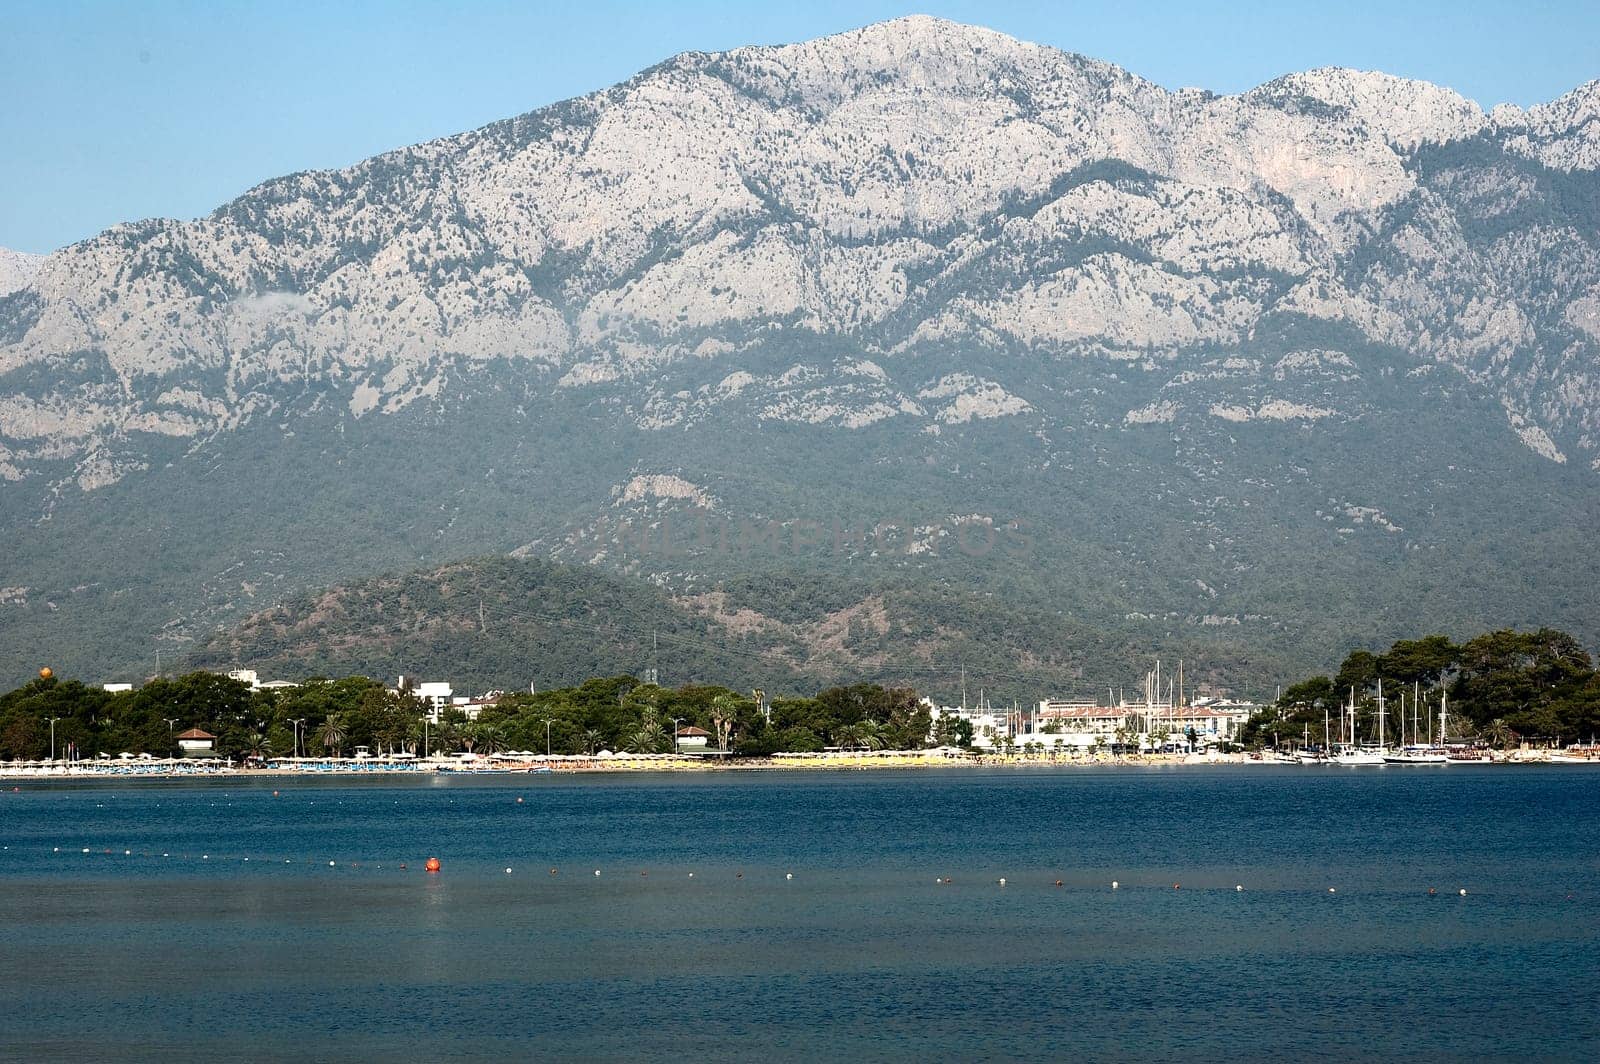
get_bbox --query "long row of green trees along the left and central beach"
[0,672,934,760]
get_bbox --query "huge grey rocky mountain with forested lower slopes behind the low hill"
[0,16,1600,688]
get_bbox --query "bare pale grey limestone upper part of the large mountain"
[0,16,1600,490]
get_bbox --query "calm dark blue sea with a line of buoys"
[0,765,1600,1062]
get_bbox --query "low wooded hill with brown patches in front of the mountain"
[187,557,1228,701]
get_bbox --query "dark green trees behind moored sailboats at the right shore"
[1246,629,1600,746]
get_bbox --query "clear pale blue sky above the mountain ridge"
[0,0,1600,251]
